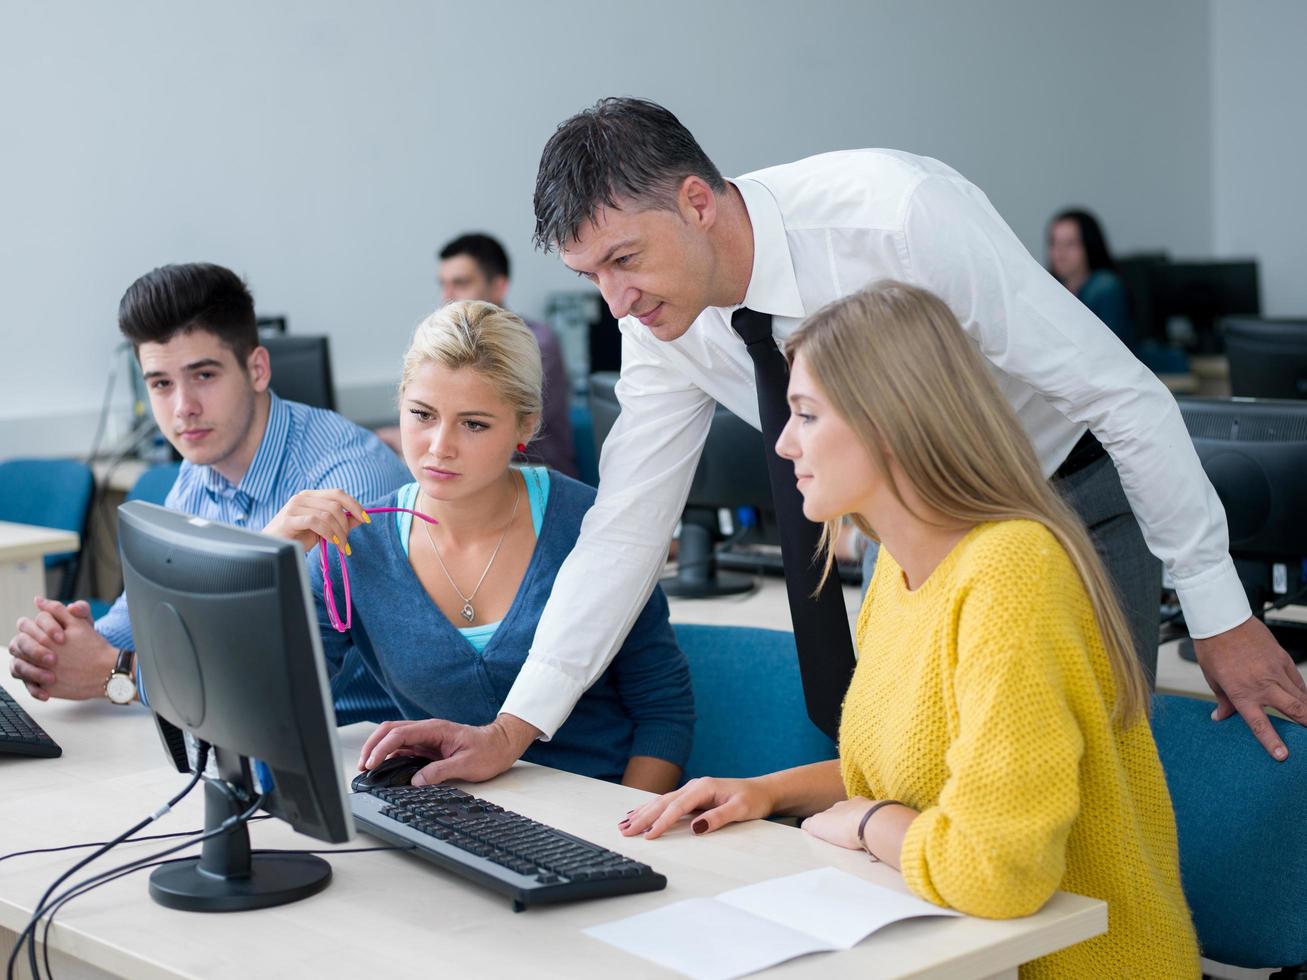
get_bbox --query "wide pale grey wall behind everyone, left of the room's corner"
[0,0,1213,457]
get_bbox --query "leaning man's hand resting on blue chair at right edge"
[1193,617,1307,762]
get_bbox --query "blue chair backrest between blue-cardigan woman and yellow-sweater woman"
[674,623,836,779]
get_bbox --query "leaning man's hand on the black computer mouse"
[358,715,540,785]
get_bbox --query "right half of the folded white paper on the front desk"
[715,868,959,950]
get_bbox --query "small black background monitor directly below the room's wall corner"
[1150,260,1261,354]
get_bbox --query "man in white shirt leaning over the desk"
[365,98,1307,779]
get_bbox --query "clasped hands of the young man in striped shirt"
[9,596,118,700]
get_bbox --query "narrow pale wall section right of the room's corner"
[1212,0,1307,316]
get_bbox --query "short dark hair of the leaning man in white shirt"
[535,98,725,252]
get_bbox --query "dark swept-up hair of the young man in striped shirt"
[118,263,259,368]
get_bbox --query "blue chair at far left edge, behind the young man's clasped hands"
[0,459,95,601]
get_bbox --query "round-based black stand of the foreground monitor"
[150,749,331,912]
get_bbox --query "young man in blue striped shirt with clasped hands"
[9,263,409,724]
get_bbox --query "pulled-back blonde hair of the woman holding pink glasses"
[400,299,544,438]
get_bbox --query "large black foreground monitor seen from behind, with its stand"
[118,500,354,912]
